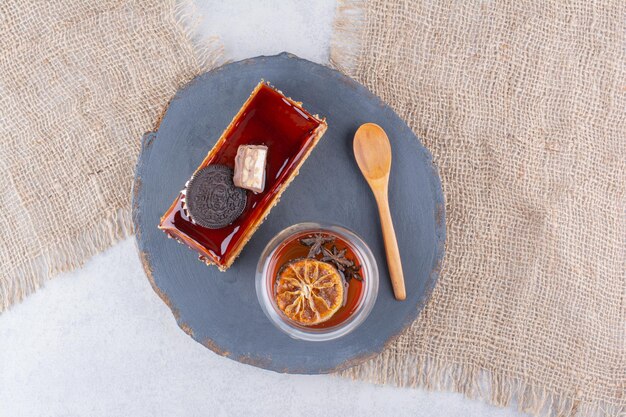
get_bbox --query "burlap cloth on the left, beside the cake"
[0,0,218,311]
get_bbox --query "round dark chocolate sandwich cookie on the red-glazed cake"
[185,165,246,229]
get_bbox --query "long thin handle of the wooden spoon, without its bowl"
[376,190,406,301]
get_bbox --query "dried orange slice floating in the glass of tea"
[276,258,344,326]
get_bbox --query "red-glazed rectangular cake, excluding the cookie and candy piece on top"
[160,84,323,266]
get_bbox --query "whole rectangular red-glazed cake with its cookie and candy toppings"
[159,82,327,271]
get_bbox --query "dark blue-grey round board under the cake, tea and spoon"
[133,53,445,374]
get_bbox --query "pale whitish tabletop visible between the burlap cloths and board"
[0,0,521,417]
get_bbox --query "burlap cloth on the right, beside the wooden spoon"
[331,0,626,416]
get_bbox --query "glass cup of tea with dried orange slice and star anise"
[256,223,378,341]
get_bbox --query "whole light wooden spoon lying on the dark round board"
[353,123,406,300]
